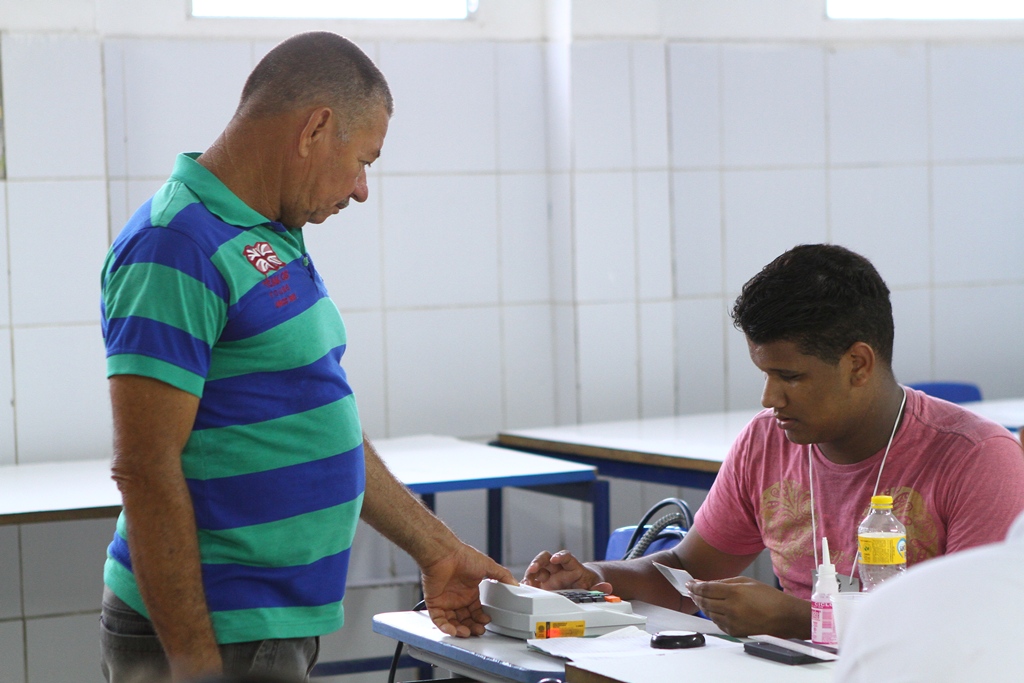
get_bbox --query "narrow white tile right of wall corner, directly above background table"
[577,303,640,422]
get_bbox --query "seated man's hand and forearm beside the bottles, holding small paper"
[686,577,811,639]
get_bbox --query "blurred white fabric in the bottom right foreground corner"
[835,514,1024,683]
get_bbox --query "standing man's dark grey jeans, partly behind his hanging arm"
[99,588,319,683]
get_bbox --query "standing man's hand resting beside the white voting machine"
[420,544,518,638]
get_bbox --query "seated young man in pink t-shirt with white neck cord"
[524,245,1024,638]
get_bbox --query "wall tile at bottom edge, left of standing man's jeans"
[26,609,103,683]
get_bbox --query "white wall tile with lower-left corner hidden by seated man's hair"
[828,166,931,289]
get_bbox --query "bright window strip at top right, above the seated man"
[825,0,1024,20]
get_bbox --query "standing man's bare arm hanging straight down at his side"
[110,375,221,681]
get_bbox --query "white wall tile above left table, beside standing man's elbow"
[14,325,113,464]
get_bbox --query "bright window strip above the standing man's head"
[191,0,478,19]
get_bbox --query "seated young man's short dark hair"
[732,245,893,368]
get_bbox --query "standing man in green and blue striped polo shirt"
[101,33,515,683]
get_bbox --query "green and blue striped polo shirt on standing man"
[102,155,365,643]
